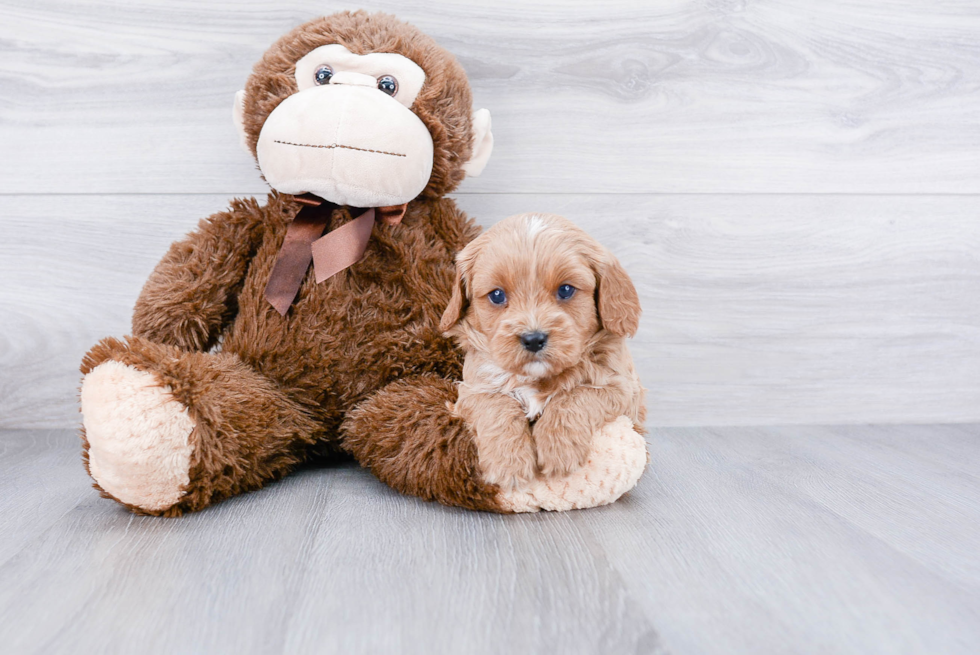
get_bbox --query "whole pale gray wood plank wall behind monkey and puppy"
[0,0,980,428]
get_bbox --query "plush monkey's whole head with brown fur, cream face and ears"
[234,11,493,207]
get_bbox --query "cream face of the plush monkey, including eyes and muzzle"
[256,44,432,207]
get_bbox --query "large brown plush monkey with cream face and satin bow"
[81,7,645,516]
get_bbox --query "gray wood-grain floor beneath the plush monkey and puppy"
[0,425,980,655]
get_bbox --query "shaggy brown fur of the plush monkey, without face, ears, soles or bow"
[82,12,500,516]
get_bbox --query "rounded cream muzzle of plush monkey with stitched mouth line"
[256,84,433,207]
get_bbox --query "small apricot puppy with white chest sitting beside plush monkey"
[440,214,646,487]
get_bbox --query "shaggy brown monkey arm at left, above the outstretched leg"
[133,199,265,351]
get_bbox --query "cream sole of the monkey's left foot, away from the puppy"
[81,360,194,513]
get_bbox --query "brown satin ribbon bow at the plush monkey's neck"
[265,193,408,316]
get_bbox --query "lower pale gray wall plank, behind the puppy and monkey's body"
[0,194,980,428]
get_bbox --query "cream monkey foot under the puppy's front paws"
[498,416,648,512]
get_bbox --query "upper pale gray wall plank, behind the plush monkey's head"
[0,0,980,194]
